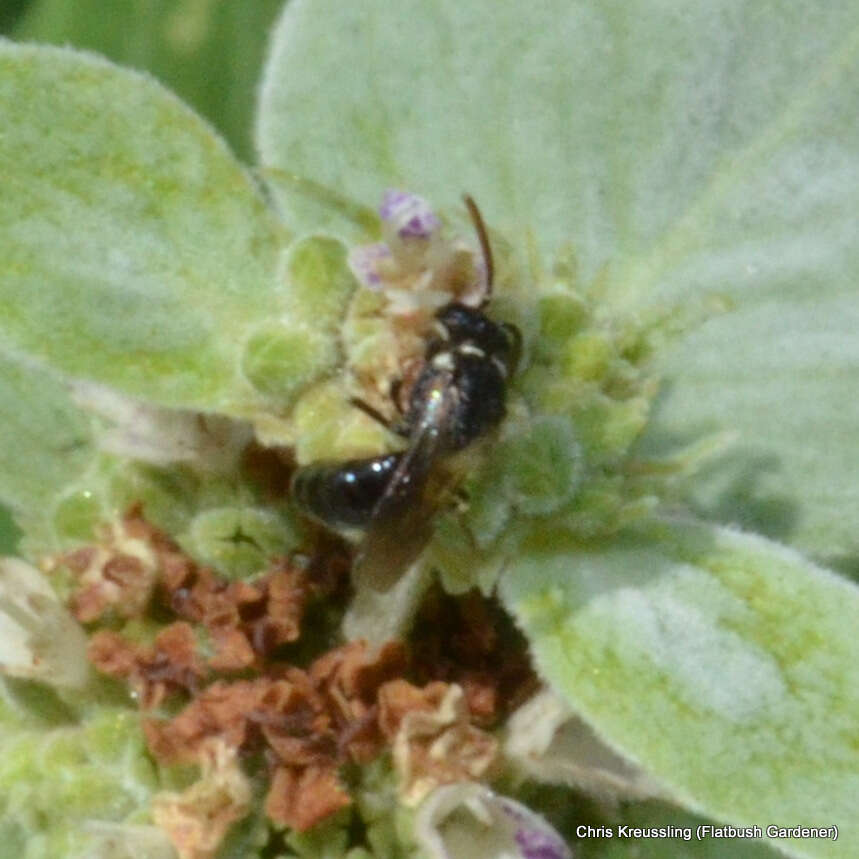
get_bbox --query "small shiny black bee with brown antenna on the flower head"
[292,196,521,590]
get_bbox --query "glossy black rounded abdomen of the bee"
[292,453,402,528]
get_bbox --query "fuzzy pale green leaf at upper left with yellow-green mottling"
[0,43,320,414]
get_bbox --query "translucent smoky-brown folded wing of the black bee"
[354,416,451,591]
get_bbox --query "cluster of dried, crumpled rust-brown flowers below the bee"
[72,507,533,848]
